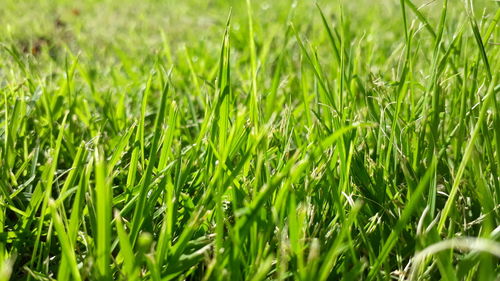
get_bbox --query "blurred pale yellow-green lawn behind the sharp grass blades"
[0,0,498,98]
